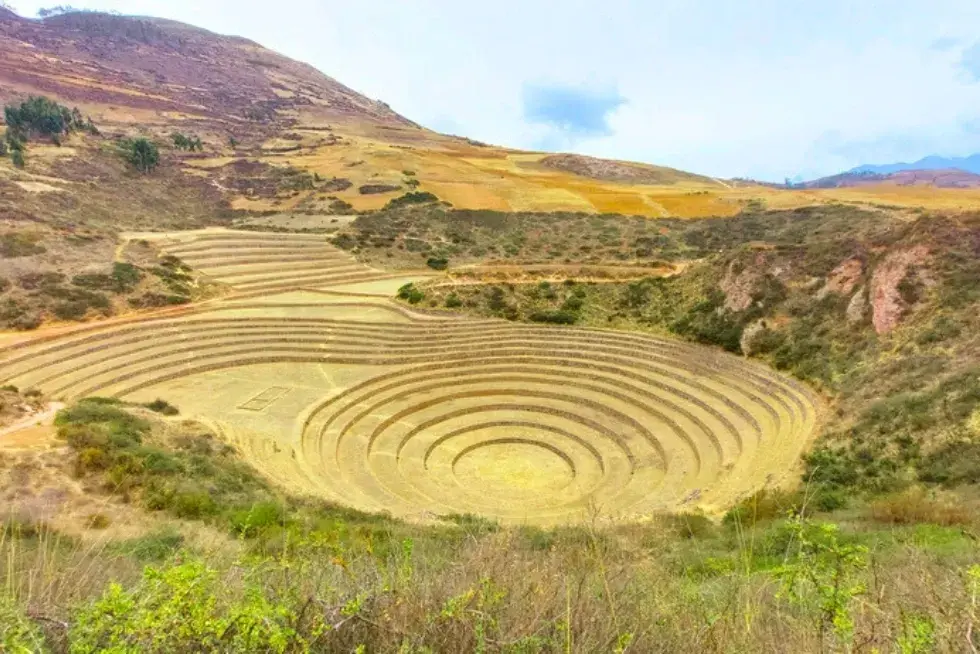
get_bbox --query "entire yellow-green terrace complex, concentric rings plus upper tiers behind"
[0,250,818,524]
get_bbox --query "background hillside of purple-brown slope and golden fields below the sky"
[0,12,980,223]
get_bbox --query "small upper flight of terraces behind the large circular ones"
[127,229,422,295]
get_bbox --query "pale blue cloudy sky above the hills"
[9,0,980,180]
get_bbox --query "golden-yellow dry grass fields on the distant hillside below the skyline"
[224,115,980,218]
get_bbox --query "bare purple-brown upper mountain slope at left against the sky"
[0,12,411,131]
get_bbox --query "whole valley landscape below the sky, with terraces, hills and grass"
[0,3,980,654]
